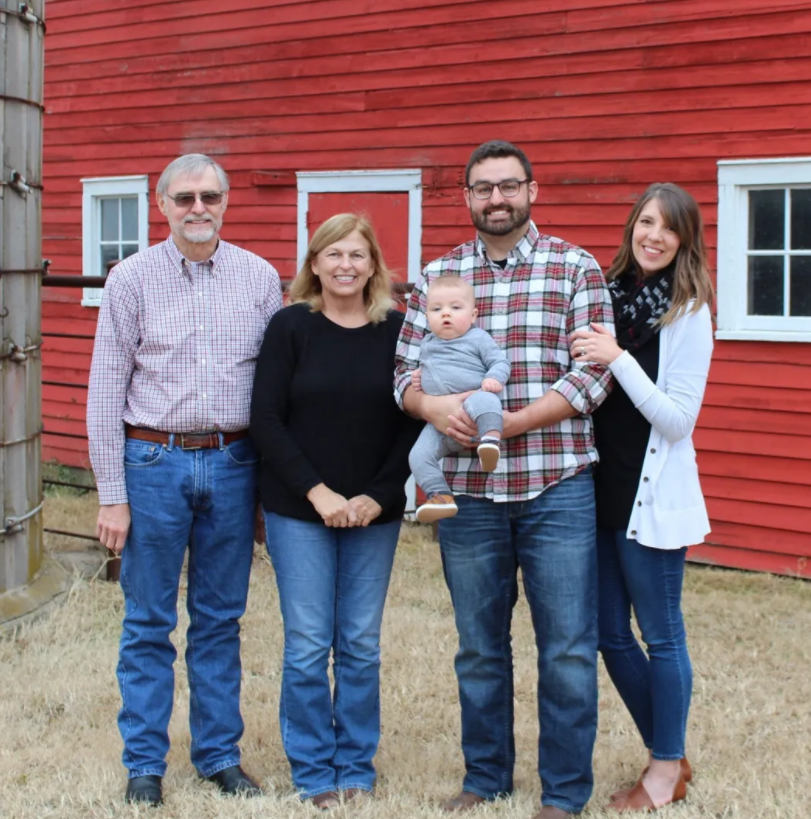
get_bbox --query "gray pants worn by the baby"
[408,390,504,498]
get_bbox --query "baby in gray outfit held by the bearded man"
[408,276,510,523]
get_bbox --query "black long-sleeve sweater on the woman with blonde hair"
[251,304,422,525]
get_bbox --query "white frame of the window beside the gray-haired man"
[81,175,149,307]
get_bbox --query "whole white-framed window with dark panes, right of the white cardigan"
[716,158,811,341]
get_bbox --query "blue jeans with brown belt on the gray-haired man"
[117,438,258,778]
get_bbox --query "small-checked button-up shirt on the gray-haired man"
[87,238,282,505]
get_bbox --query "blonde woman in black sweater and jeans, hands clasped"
[251,213,421,810]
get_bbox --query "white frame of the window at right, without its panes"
[715,157,811,341]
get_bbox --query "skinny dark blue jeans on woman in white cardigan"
[597,527,693,759]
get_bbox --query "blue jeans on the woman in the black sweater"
[265,512,400,798]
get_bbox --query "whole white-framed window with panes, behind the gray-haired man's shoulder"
[82,176,149,306]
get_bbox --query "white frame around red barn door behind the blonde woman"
[296,168,422,282]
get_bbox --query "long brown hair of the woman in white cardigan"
[605,182,713,327]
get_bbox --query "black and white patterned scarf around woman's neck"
[608,265,675,350]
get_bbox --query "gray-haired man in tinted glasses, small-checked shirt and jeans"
[87,154,282,805]
